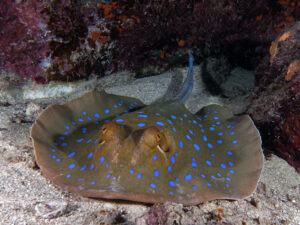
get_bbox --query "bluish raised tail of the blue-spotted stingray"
[173,52,194,102]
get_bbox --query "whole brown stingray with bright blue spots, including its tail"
[31,56,263,205]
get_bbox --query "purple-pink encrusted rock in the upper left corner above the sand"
[0,0,49,82]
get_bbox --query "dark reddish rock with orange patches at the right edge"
[248,22,300,172]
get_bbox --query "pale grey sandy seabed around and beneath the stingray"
[0,67,300,225]
